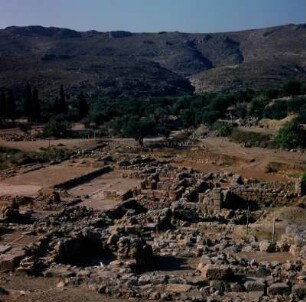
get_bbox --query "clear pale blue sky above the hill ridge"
[0,0,306,32]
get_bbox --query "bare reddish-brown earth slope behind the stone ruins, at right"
[175,137,306,181]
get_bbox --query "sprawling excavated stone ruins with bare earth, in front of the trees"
[0,138,306,302]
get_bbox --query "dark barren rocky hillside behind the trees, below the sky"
[0,24,306,97]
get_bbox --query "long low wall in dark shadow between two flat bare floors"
[53,166,113,190]
